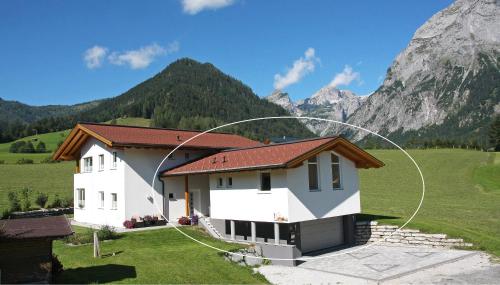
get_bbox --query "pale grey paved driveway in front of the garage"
[259,245,500,284]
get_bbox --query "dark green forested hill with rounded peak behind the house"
[0,58,313,142]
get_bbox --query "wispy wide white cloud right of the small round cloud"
[108,41,179,69]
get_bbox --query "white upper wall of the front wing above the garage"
[210,152,360,223]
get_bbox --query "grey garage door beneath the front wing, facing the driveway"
[300,217,344,253]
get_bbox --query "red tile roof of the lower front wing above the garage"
[163,137,336,176]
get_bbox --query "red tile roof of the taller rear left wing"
[80,123,261,149]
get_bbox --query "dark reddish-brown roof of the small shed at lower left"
[0,216,73,239]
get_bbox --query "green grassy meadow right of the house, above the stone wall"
[361,149,500,256]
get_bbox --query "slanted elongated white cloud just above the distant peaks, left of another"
[274,48,319,89]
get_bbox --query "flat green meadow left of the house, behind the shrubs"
[0,162,75,212]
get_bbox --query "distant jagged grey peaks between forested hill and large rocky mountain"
[266,86,367,135]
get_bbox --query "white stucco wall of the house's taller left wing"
[74,138,208,227]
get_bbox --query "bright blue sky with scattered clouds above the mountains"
[0,0,452,105]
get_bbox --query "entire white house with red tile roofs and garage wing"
[54,124,383,262]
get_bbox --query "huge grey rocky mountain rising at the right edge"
[327,0,500,144]
